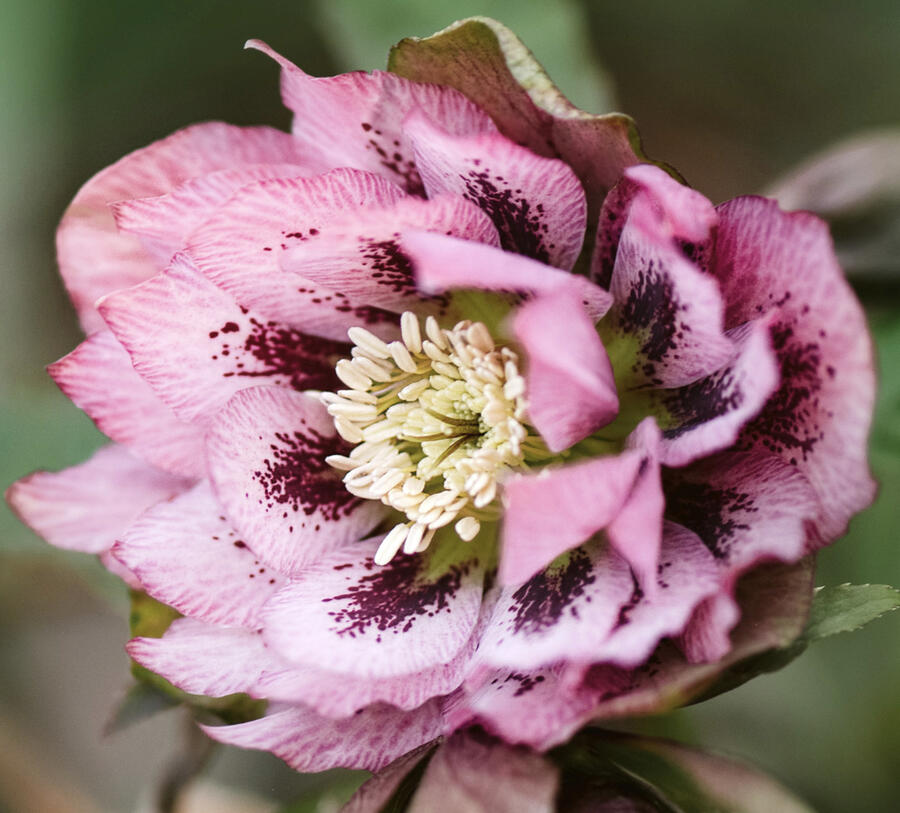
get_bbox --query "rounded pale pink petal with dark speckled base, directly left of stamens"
[207,387,384,574]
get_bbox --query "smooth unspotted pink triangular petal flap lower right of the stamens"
[498,451,642,585]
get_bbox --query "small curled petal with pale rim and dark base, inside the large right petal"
[651,318,779,466]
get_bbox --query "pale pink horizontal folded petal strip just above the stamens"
[401,231,613,320]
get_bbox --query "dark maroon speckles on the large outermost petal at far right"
[739,323,835,465]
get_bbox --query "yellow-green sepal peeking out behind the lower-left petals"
[127,590,267,725]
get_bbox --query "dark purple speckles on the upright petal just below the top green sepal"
[462,170,553,263]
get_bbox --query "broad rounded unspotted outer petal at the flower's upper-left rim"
[56,122,321,333]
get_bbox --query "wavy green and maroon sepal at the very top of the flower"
[388,17,680,224]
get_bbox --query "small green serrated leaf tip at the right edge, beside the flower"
[801,584,900,643]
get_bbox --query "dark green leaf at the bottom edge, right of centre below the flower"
[551,729,810,813]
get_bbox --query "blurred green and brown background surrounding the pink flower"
[0,0,900,813]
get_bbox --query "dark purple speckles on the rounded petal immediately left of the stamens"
[253,427,360,532]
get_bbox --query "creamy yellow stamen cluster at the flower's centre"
[322,311,540,564]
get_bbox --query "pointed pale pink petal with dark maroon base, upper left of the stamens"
[98,253,349,424]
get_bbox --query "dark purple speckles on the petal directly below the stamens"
[322,556,469,642]
